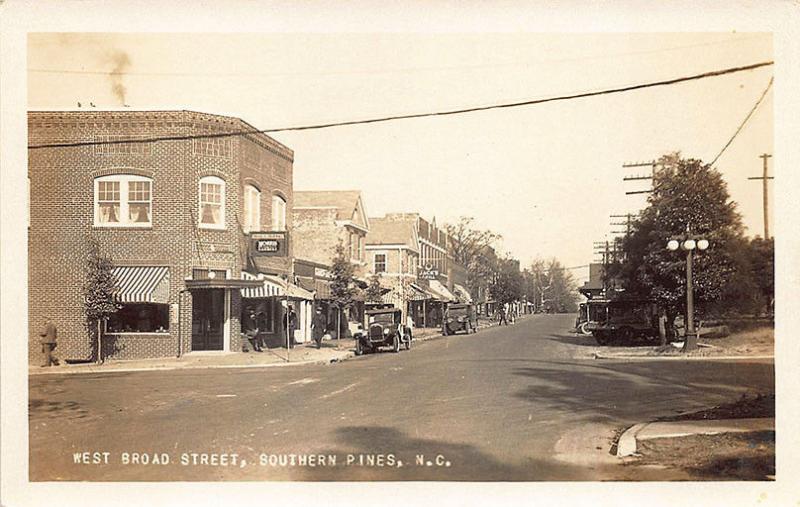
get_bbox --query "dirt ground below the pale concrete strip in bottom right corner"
[631,431,775,481]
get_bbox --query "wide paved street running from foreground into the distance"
[30,315,774,481]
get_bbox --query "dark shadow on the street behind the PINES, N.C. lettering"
[291,426,585,482]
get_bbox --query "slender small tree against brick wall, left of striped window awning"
[83,239,122,362]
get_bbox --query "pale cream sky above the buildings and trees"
[27,32,777,281]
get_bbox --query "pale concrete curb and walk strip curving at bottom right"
[617,417,775,458]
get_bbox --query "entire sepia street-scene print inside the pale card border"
[3,1,796,505]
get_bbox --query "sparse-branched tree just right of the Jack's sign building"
[445,217,501,304]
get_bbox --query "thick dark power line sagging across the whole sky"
[28,61,774,150]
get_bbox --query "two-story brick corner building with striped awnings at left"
[28,111,294,363]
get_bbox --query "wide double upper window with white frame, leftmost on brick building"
[94,174,153,227]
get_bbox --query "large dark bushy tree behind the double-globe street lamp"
[609,153,747,326]
